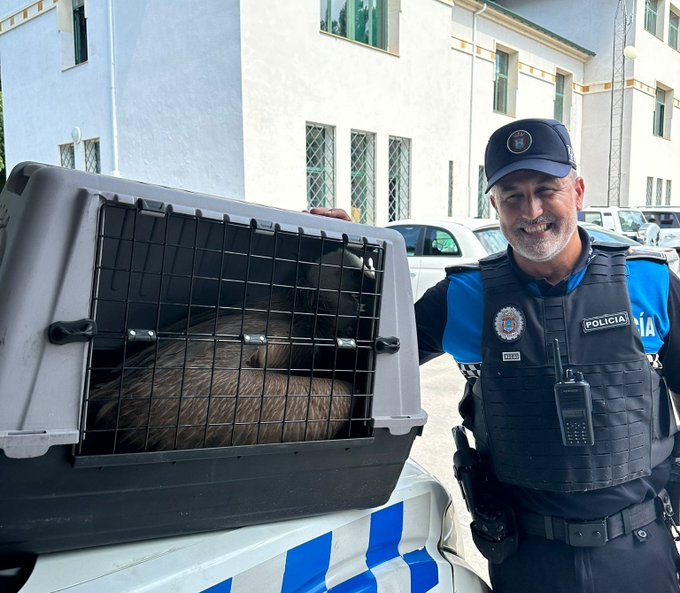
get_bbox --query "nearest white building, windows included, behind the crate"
[0,0,596,224]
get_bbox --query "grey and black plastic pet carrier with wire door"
[0,163,426,554]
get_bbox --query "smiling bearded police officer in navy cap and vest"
[416,119,680,593]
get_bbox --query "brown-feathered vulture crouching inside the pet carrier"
[84,217,377,453]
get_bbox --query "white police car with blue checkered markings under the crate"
[10,460,490,593]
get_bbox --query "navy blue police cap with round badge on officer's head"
[484,119,576,192]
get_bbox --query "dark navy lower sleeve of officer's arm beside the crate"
[416,278,449,364]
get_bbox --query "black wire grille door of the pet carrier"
[80,203,384,454]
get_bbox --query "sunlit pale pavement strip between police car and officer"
[411,355,489,582]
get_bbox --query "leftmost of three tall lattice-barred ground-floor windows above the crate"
[307,124,335,208]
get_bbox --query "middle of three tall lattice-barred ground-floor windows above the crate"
[350,131,375,224]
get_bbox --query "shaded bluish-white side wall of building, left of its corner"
[0,0,244,198]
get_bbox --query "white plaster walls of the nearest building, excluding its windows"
[0,0,585,217]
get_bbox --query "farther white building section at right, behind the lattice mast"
[498,0,680,206]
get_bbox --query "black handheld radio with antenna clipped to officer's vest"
[553,340,595,447]
